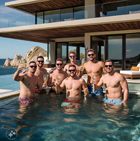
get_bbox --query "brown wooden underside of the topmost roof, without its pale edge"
[11,0,84,13]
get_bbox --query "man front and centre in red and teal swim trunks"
[55,65,89,102]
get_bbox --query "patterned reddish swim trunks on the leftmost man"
[18,97,37,106]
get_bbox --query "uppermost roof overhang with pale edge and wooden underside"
[5,0,84,14]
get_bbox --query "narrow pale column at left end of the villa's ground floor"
[49,42,55,64]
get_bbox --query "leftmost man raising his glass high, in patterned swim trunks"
[13,61,46,106]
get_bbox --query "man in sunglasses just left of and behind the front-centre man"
[48,58,68,94]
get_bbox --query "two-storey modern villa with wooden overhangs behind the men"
[0,0,140,69]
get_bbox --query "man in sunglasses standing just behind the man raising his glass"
[35,56,47,94]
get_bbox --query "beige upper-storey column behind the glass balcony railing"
[85,0,96,19]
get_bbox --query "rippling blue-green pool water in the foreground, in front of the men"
[0,95,140,141]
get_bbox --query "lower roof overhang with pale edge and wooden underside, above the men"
[0,14,140,43]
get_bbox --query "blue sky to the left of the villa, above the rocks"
[0,0,47,59]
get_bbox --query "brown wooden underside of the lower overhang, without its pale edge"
[0,21,140,43]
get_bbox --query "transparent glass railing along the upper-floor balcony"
[0,0,140,28]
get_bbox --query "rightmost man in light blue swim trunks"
[95,60,129,106]
